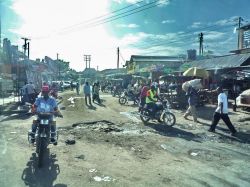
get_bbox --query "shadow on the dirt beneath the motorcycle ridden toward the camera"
[21,150,67,187]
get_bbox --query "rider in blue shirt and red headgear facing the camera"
[30,85,62,145]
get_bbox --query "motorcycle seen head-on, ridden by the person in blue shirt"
[28,113,62,168]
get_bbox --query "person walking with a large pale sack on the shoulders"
[183,86,198,122]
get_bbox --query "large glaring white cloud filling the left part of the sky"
[12,0,124,71]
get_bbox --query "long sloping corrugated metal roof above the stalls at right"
[187,53,250,70]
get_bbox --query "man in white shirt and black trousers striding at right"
[208,87,237,136]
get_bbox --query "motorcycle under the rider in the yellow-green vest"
[139,100,176,126]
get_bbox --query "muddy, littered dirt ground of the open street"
[0,91,250,187]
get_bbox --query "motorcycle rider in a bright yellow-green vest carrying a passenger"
[146,85,158,116]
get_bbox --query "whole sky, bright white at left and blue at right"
[0,0,250,71]
